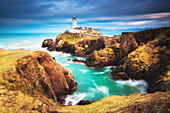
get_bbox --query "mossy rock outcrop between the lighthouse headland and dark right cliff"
[86,35,138,67]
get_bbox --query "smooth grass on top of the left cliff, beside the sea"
[0,49,34,88]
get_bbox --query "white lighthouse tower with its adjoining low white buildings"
[70,16,100,34]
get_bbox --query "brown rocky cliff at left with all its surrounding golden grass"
[0,49,77,112]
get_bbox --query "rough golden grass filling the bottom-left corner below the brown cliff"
[0,85,38,113]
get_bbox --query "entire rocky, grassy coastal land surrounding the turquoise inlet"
[0,27,170,113]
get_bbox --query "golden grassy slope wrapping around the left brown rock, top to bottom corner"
[0,49,57,113]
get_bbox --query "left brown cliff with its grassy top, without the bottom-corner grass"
[0,50,77,105]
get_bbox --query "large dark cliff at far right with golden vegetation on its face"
[112,28,170,93]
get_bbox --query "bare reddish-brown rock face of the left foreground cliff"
[16,52,77,101]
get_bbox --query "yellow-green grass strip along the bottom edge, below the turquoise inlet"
[51,93,169,113]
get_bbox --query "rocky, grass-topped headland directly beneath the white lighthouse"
[42,32,105,56]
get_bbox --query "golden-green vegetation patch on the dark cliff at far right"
[127,36,166,72]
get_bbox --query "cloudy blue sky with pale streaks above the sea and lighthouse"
[0,0,170,35]
